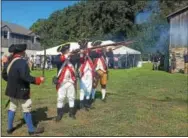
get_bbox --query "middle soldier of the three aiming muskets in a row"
[78,39,94,110]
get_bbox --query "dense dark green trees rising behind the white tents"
[31,0,188,52]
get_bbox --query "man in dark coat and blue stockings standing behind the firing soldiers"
[2,44,44,135]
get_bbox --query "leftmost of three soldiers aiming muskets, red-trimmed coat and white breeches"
[53,44,76,122]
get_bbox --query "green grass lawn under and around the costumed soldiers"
[1,64,188,136]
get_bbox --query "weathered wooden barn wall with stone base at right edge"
[169,10,188,72]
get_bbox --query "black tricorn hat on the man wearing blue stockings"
[8,44,27,53]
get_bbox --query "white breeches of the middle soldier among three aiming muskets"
[80,71,93,100]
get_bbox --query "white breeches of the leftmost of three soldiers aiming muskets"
[57,82,75,108]
